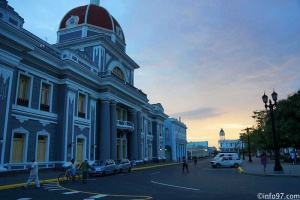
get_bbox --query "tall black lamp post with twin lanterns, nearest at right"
[262,90,283,171]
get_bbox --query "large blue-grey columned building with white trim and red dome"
[0,0,169,170]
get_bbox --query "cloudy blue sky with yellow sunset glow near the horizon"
[8,0,300,147]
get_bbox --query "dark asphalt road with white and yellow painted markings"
[0,159,300,200]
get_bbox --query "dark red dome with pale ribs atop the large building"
[59,4,125,43]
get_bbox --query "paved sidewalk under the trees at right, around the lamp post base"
[238,157,300,177]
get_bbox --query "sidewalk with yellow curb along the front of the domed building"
[0,162,180,191]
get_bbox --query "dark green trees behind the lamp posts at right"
[250,90,300,152]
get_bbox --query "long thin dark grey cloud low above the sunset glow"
[171,107,224,120]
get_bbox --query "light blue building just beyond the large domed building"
[162,118,187,162]
